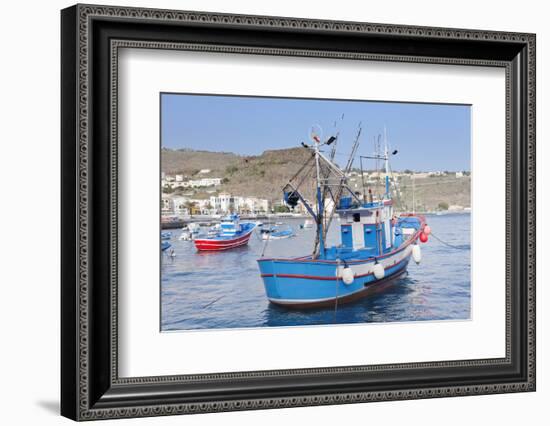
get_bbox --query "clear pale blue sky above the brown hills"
[161,93,471,171]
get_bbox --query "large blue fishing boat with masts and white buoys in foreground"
[258,125,430,308]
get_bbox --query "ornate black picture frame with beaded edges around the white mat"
[61,5,535,420]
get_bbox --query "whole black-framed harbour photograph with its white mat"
[61,5,535,420]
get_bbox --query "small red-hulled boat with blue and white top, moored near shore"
[194,214,256,251]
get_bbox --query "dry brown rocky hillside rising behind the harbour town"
[162,148,471,211]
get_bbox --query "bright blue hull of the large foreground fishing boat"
[258,244,412,309]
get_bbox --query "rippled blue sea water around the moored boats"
[161,214,470,331]
